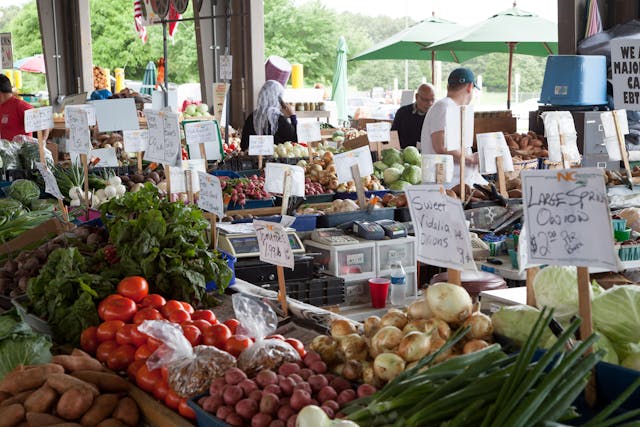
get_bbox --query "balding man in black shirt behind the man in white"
[391,83,436,148]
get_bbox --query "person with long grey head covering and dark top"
[240,80,298,150]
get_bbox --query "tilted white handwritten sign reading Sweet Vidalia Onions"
[406,185,476,271]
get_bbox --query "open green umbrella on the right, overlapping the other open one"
[428,3,558,108]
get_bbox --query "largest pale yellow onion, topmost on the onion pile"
[426,283,473,323]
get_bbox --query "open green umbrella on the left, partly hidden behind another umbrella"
[351,16,482,83]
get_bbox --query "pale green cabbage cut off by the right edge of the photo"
[592,285,640,346]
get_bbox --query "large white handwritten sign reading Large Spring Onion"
[521,168,618,271]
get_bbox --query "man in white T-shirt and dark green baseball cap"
[420,68,486,187]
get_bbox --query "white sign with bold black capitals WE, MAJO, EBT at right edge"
[611,38,640,111]
